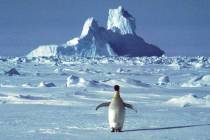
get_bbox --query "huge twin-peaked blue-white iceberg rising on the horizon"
[27,6,164,58]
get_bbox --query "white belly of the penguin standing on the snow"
[109,103,125,129]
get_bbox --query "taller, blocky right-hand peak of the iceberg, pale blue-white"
[107,6,136,35]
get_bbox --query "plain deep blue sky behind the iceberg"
[0,0,210,56]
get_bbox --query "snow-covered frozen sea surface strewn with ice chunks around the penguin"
[0,57,210,140]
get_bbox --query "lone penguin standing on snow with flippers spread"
[96,85,137,132]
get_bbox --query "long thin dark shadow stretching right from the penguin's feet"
[123,124,210,132]
